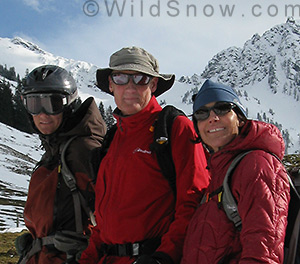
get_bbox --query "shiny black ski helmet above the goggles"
[21,65,78,104]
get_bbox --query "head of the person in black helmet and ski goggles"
[21,65,79,135]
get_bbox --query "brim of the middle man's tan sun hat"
[96,64,175,97]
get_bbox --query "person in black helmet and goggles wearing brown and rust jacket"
[16,65,106,264]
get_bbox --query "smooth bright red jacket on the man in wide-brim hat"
[80,97,209,264]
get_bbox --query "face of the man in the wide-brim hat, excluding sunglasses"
[109,71,158,115]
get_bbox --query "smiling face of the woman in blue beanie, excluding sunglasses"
[197,102,244,152]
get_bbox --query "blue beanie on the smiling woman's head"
[193,80,247,118]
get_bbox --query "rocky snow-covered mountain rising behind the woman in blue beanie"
[179,18,300,153]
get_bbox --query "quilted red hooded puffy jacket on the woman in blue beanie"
[181,121,290,264]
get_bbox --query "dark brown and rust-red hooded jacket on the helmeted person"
[24,98,106,264]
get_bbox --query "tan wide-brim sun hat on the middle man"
[96,47,175,97]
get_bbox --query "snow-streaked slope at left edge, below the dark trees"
[0,123,42,230]
